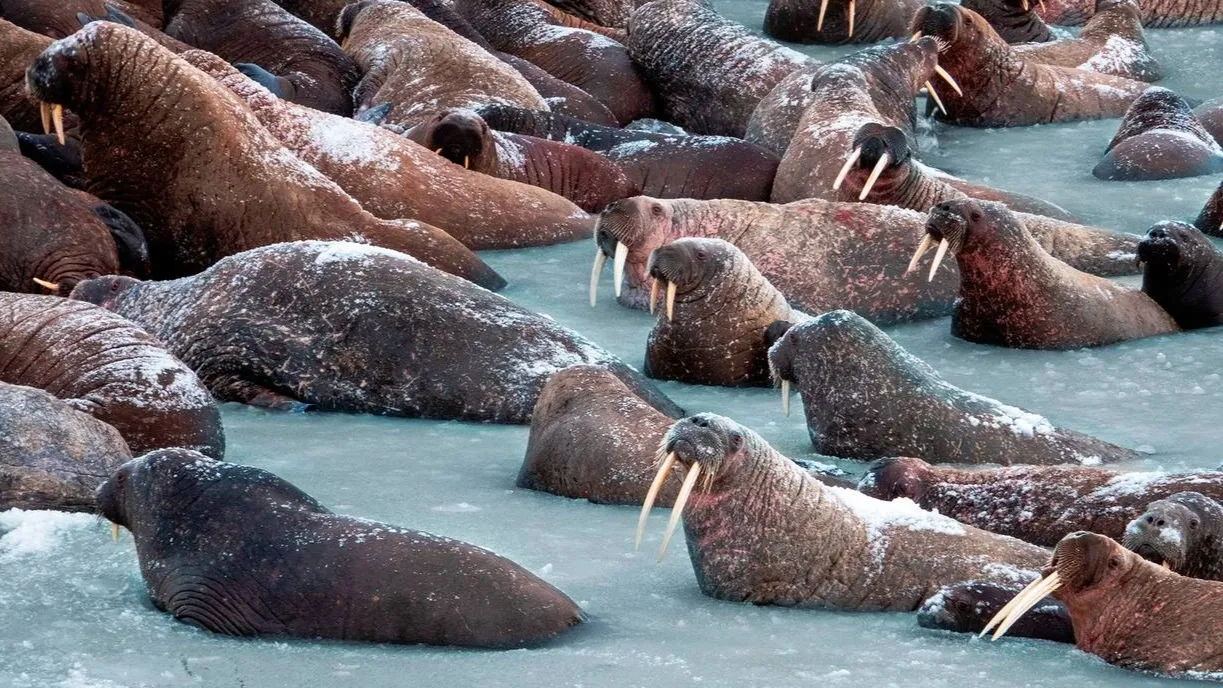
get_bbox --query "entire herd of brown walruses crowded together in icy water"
[0,0,1223,678]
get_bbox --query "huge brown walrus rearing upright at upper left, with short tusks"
[28,22,505,288]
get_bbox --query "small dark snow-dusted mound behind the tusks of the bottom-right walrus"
[917,580,1074,644]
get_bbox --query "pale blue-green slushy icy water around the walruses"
[0,5,1223,688]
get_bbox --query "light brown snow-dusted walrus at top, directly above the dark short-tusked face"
[336,0,548,128]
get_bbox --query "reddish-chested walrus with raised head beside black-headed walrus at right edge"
[912,200,1180,349]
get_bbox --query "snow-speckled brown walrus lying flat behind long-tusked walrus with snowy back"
[859,458,1223,546]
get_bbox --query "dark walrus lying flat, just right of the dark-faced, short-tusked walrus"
[479,105,779,200]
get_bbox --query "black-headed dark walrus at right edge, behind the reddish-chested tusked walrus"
[1139,222,1223,330]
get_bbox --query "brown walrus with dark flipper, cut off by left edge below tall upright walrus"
[0,119,148,295]
